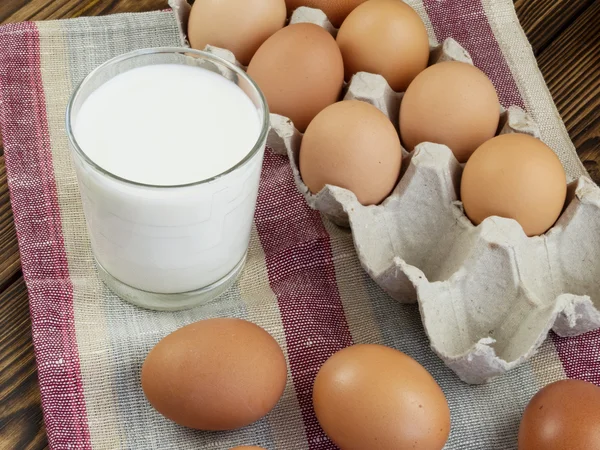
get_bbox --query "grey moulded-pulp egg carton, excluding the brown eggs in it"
[169,0,600,384]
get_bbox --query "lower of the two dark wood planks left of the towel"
[0,278,47,450]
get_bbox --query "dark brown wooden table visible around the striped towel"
[0,0,600,450]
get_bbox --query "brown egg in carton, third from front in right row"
[337,0,429,92]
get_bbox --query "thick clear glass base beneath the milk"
[94,255,246,311]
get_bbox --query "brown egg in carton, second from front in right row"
[400,61,500,162]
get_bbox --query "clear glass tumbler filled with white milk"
[66,48,269,310]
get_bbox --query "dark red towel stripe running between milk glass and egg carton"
[255,149,352,450]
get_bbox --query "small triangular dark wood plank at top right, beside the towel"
[515,0,596,55]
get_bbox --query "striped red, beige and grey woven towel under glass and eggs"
[0,0,600,450]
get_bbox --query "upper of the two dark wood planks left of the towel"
[0,156,21,292]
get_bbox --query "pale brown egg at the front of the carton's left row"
[300,100,402,205]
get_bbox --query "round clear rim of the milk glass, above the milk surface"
[66,47,270,189]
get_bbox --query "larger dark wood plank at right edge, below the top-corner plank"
[538,1,600,184]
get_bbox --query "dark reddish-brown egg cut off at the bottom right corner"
[519,380,600,450]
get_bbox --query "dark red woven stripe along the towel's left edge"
[0,23,91,449]
